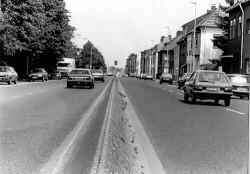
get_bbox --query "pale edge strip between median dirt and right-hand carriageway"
[118,80,166,174]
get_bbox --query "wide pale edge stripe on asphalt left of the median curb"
[39,79,113,174]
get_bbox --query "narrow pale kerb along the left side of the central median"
[90,79,116,174]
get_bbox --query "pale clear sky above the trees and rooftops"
[65,0,228,67]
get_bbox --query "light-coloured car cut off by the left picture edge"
[0,66,18,85]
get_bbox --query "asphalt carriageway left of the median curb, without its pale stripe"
[0,78,111,174]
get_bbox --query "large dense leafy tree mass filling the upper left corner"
[0,0,74,75]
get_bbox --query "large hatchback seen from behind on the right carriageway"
[184,70,233,106]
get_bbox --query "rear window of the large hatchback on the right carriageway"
[198,72,229,83]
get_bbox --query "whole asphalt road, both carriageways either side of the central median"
[0,77,248,174]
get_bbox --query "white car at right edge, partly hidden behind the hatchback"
[227,74,249,98]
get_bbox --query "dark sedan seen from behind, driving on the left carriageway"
[67,68,95,88]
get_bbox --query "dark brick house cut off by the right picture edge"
[224,0,250,74]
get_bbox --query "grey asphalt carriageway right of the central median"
[120,78,248,174]
